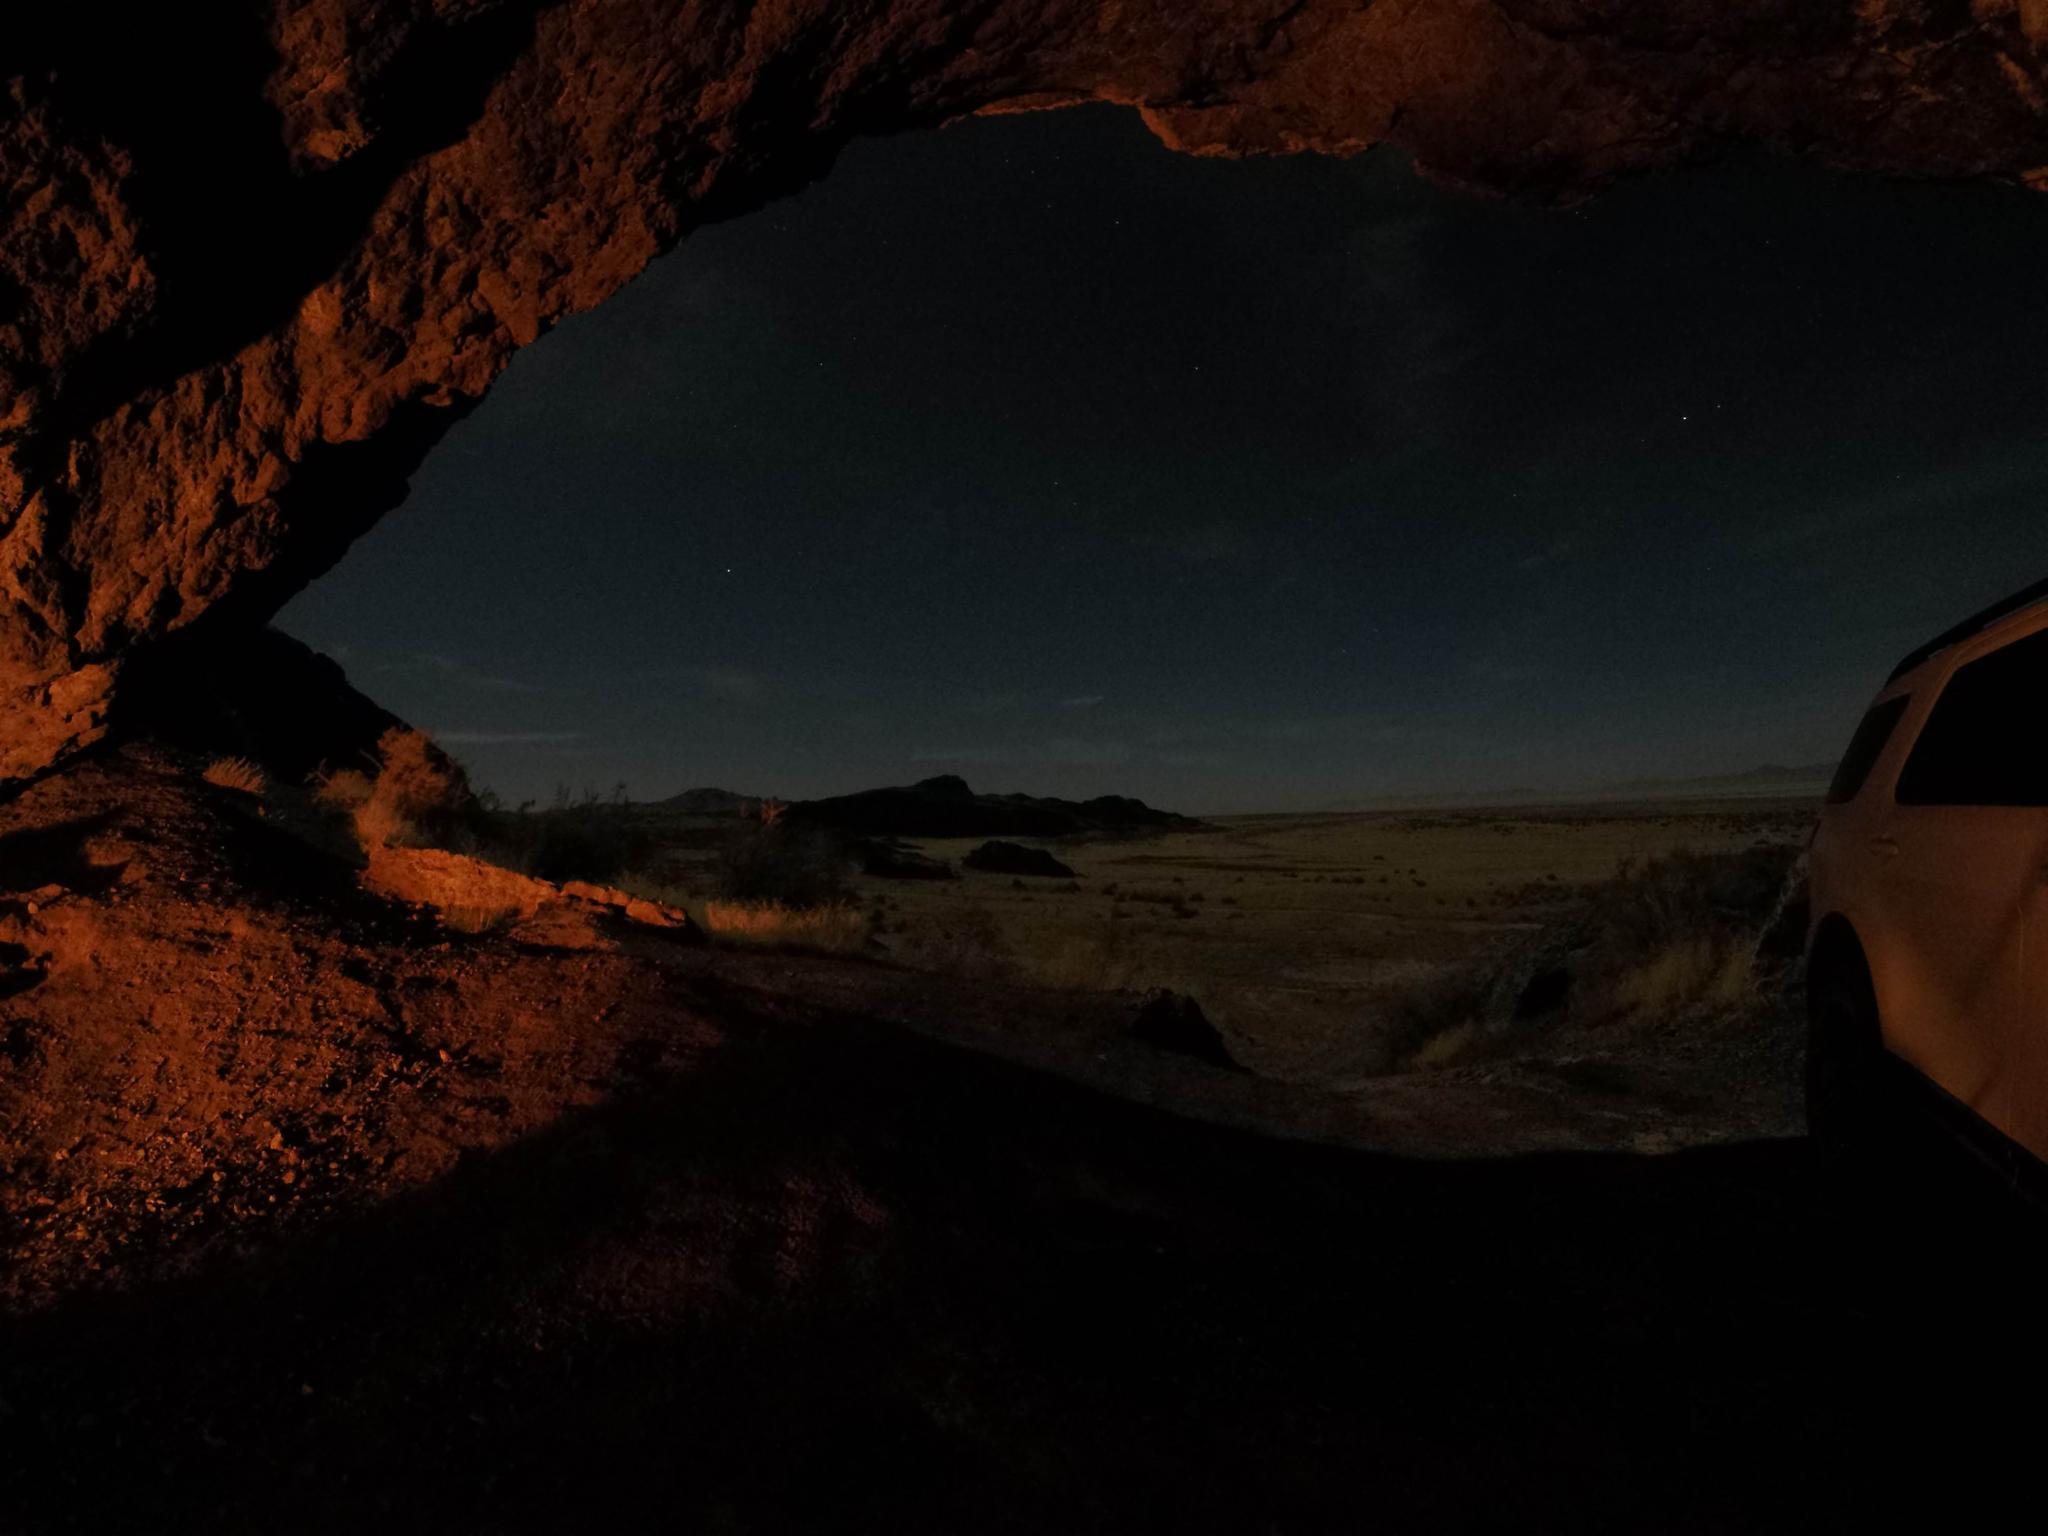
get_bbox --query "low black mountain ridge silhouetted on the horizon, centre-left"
[788,774,1202,838]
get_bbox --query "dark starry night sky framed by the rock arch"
[281,109,2048,813]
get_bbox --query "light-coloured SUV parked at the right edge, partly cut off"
[1806,582,2048,1165]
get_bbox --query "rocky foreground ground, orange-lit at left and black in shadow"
[0,748,2040,1532]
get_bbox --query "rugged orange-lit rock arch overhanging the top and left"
[0,0,2048,784]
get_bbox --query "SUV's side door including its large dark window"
[1872,629,2048,1135]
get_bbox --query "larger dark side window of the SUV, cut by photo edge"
[1898,631,2048,805]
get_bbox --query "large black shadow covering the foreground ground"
[0,978,2038,1532]
